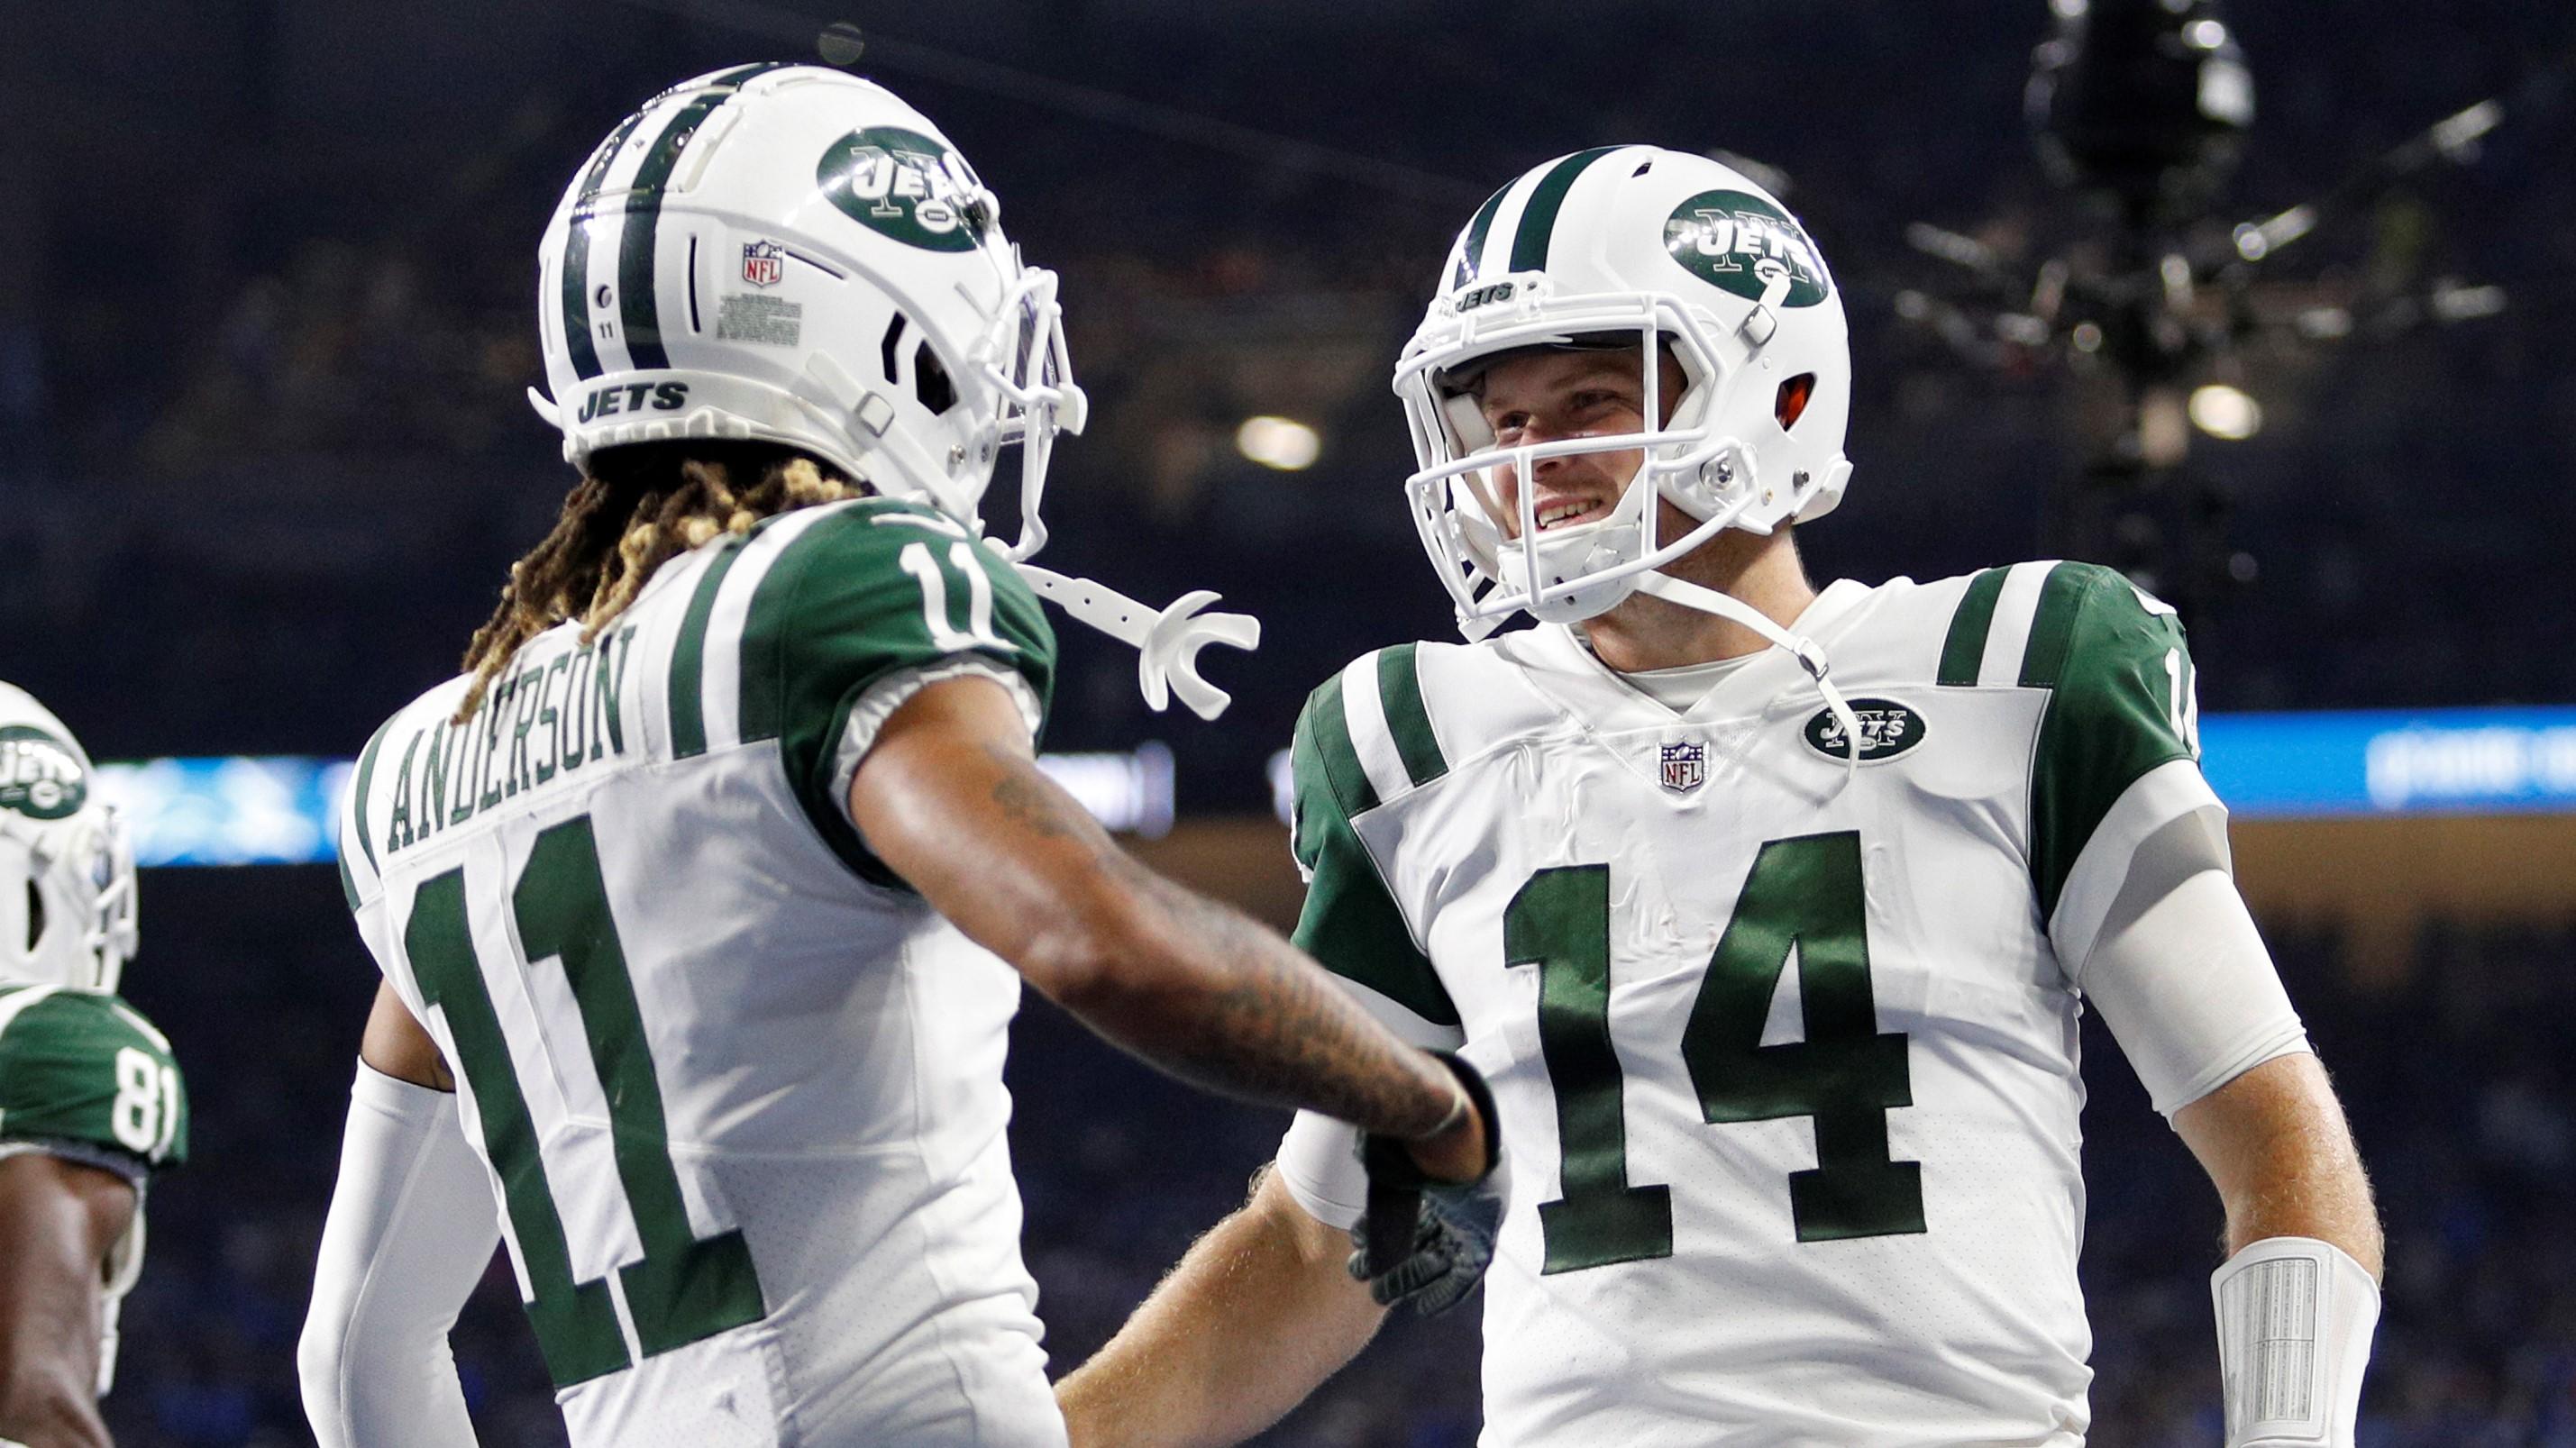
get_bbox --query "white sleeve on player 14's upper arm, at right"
[2069,815,2308,1116]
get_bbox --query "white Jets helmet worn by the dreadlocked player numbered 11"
[528,64,1084,559]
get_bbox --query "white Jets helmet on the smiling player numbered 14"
[1393,147,1852,636]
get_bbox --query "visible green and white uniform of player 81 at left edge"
[0,984,188,1394]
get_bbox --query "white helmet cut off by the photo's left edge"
[0,683,134,989]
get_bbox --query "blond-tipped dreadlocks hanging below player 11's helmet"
[456,441,865,724]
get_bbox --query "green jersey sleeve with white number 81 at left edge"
[0,989,188,1167]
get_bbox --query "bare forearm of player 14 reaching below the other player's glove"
[1056,1172,1386,1448]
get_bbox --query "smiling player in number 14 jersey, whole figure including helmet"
[1061,147,2380,1448]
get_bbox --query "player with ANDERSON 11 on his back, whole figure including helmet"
[299,64,1499,1448]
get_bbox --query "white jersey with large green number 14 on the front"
[1280,564,2218,1448]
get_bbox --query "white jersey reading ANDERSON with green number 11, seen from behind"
[340,500,1064,1448]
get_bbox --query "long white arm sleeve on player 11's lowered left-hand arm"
[297,1061,499,1448]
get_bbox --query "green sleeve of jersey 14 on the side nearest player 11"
[1288,675,1458,1025]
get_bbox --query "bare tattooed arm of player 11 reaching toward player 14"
[850,678,1484,1164]
